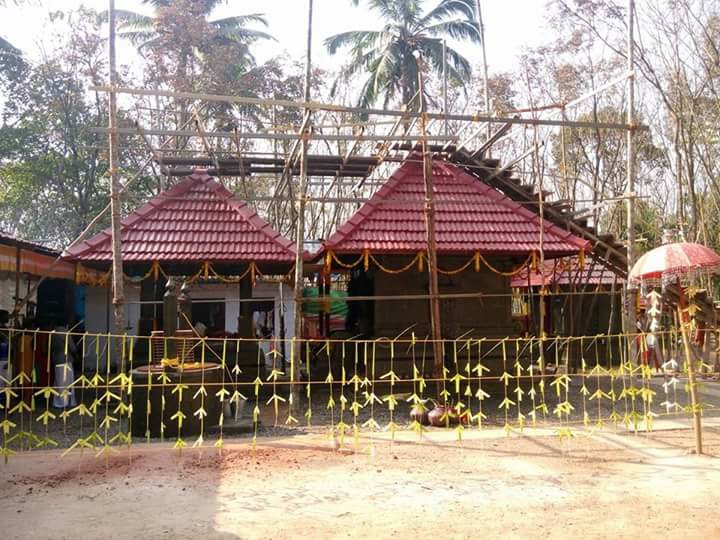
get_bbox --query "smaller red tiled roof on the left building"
[65,171,295,263]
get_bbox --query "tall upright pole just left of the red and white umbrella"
[625,0,637,358]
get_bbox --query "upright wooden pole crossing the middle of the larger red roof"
[417,56,444,394]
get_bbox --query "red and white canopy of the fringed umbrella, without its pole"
[628,242,720,286]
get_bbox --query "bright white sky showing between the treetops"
[0,0,546,78]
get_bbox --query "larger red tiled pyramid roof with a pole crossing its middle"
[323,161,589,256]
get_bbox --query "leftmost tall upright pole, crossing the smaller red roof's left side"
[108,0,125,350]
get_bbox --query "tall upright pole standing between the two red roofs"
[290,0,313,413]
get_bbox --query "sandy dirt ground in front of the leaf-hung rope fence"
[0,426,720,540]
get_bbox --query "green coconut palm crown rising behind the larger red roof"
[325,0,480,109]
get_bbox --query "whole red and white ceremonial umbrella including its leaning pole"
[628,231,720,454]
